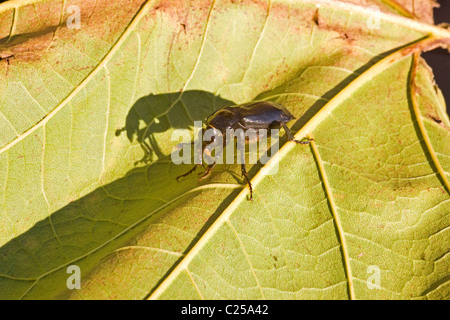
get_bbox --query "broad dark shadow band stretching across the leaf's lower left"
[0,160,244,299]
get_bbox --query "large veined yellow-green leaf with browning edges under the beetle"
[0,0,450,299]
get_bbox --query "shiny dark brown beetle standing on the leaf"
[176,101,313,200]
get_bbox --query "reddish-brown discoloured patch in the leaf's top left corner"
[0,0,143,63]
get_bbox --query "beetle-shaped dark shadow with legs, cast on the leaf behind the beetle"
[116,90,235,164]
